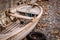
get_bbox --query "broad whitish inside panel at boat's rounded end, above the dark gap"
[11,5,40,14]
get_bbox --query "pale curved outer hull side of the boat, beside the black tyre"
[9,2,43,40]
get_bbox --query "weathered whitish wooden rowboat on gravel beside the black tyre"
[0,4,43,40]
